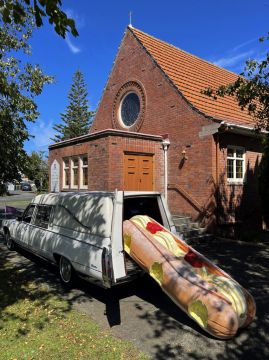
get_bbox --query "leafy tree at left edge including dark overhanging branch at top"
[0,0,77,193]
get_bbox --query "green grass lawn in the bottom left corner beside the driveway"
[0,250,147,360]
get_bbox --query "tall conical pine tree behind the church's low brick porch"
[52,70,94,142]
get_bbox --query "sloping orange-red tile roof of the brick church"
[129,27,254,127]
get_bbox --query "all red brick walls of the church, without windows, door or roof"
[50,30,261,233]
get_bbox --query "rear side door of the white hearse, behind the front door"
[29,205,54,258]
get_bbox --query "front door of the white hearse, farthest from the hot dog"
[14,204,36,247]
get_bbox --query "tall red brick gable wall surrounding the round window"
[91,30,215,224]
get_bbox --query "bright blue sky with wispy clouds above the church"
[25,0,269,152]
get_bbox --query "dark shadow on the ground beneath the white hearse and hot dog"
[0,239,202,344]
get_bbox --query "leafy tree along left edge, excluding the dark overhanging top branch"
[0,9,52,188]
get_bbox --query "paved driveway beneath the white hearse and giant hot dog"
[0,236,269,360]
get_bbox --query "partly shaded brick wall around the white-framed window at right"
[216,134,262,233]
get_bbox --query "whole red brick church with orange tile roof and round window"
[49,26,261,231]
